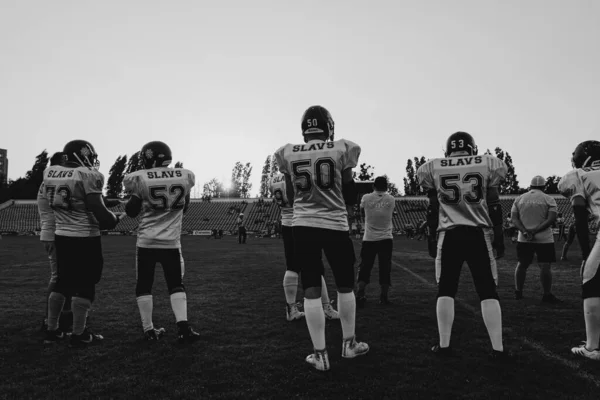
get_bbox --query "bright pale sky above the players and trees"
[0,0,600,194]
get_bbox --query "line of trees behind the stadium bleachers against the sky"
[0,147,560,203]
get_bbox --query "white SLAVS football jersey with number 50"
[275,139,360,231]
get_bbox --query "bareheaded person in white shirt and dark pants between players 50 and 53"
[356,176,396,307]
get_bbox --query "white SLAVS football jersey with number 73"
[43,165,104,237]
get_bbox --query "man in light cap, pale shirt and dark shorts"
[511,175,561,303]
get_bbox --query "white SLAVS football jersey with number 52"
[123,167,196,249]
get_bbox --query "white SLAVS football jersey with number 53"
[417,154,507,231]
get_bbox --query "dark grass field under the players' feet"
[0,236,600,399]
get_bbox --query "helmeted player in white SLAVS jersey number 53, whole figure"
[417,132,507,359]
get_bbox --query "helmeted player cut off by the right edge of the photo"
[558,140,600,361]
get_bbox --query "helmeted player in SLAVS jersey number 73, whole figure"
[43,140,120,347]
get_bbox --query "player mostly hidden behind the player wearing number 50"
[271,173,340,321]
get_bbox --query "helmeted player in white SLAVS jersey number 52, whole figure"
[123,142,200,343]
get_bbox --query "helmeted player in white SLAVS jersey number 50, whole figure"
[275,106,369,371]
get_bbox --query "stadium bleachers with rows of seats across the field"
[0,195,593,233]
